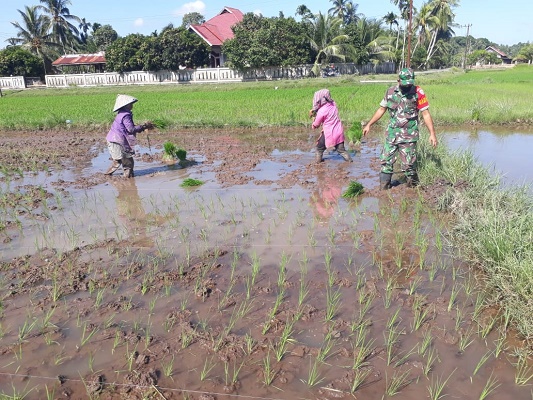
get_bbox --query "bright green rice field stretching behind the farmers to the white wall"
[0,66,533,130]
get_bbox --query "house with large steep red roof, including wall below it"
[189,7,243,67]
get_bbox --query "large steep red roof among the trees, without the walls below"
[190,7,243,46]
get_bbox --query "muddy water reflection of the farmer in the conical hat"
[112,179,153,247]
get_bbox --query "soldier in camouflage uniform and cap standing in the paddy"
[363,68,438,190]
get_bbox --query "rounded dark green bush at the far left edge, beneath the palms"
[0,46,44,77]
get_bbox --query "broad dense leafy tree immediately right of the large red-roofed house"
[222,13,311,71]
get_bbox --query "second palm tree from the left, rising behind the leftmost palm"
[37,0,81,54]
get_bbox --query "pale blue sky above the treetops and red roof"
[0,0,533,48]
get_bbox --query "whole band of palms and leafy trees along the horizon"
[0,0,533,76]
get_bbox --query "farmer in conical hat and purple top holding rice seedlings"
[105,94,153,178]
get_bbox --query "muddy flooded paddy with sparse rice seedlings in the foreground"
[0,128,533,400]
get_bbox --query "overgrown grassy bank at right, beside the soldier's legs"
[420,137,533,344]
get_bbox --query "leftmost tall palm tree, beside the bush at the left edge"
[8,6,57,71]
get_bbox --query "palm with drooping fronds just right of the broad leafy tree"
[309,12,355,76]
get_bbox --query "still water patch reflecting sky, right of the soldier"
[441,128,533,190]
